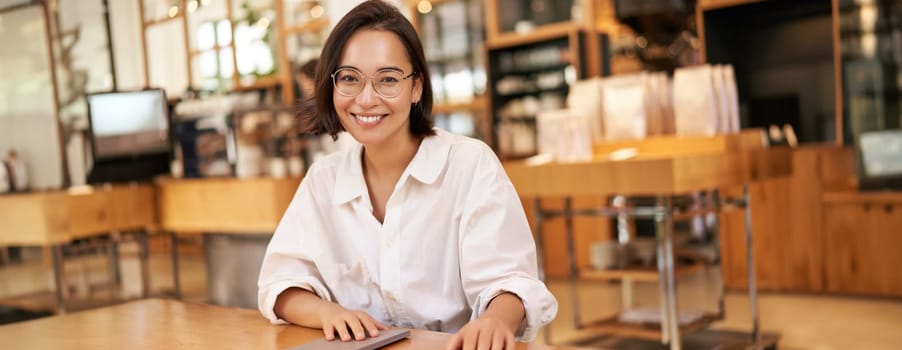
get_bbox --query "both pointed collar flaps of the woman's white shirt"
[332,128,451,205]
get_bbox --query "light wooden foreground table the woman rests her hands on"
[0,299,592,350]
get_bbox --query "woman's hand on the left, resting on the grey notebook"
[319,303,388,341]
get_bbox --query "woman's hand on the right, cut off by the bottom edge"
[445,315,516,350]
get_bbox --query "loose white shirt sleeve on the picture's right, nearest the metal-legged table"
[459,146,557,341]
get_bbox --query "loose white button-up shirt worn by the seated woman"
[258,129,557,341]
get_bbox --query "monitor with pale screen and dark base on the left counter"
[86,89,171,183]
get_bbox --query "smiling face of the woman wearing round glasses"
[332,29,422,146]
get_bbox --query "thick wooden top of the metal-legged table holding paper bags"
[504,148,792,197]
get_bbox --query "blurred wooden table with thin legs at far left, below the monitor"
[0,184,156,312]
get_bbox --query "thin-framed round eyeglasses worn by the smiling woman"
[332,68,417,98]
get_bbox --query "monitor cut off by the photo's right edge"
[857,129,902,191]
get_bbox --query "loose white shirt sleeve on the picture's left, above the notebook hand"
[257,169,332,324]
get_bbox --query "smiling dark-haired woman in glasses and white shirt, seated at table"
[259,0,557,349]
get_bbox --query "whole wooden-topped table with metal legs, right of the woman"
[505,148,792,350]
